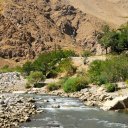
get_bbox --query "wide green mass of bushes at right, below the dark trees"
[88,55,128,85]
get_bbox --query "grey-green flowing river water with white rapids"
[21,95,128,128]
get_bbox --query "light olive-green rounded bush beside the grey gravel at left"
[27,71,44,84]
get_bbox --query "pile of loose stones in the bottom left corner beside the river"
[0,94,36,128]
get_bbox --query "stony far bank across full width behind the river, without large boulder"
[0,72,128,108]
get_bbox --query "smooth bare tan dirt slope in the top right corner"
[66,0,128,26]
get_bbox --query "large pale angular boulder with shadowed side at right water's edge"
[102,96,128,110]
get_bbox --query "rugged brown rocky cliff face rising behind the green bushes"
[0,0,104,61]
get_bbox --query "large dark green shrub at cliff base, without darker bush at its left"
[33,50,75,77]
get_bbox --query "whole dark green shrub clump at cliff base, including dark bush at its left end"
[23,50,76,77]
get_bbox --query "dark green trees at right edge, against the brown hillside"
[99,24,128,53]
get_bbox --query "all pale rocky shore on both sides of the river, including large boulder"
[0,72,128,128]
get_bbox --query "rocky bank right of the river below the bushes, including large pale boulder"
[28,82,128,111]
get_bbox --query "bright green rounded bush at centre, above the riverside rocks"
[63,77,88,93]
